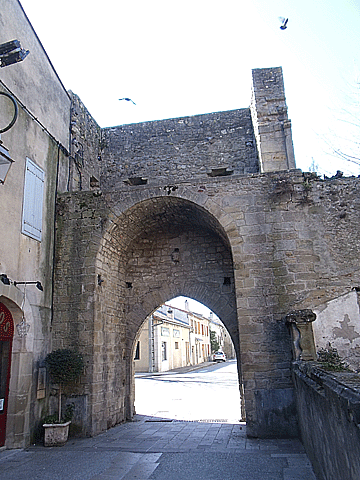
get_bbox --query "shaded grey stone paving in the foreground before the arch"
[0,415,316,480]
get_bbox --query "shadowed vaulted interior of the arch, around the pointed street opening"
[94,196,239,423]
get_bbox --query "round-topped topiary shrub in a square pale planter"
[43,349,84,447]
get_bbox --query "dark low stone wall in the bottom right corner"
[294,362,360,480]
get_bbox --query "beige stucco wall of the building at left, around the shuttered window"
[0,0,70,448]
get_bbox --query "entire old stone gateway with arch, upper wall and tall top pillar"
[52,68,360,437]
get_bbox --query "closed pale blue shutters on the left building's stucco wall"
[21,158,45,242]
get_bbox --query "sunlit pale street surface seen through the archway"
[135,360,241,423]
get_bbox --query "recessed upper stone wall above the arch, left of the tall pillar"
[101,109,259,190]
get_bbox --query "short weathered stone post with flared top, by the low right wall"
[284,310,316,361]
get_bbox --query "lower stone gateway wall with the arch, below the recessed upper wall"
[54,171,360,436]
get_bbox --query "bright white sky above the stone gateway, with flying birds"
[21,0,360,176]
